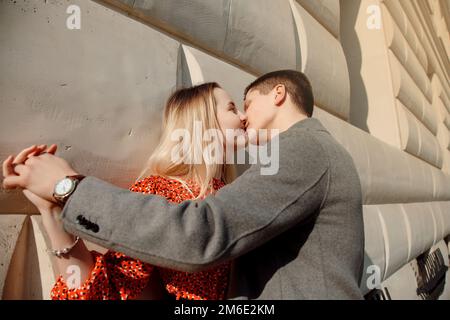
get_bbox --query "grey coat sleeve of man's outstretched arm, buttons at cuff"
[62,132,329,272]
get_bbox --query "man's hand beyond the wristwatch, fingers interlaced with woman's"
[3,145,77,202]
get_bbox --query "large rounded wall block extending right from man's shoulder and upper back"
[314,108,450,204]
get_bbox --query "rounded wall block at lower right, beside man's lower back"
[364,202,450,279]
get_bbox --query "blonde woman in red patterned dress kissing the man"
[19,83,246,300]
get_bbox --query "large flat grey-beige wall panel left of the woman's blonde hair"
[0,1,179,212]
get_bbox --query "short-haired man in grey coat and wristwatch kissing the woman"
[4,70,364,299]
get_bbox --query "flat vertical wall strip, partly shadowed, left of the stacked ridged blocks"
[340,0,401,148]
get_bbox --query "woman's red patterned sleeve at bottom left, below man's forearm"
[51,251,153,300]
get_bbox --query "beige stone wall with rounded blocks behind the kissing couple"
[0,0,450,299]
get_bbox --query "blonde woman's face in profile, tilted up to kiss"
[214,88,247,147]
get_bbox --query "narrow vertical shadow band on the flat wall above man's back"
[340,0,369,133]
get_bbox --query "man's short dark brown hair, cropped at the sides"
[244,70,314,118]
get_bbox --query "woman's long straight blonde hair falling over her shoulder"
[138,82,236,198]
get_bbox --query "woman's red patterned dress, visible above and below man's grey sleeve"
[51,176,230,300]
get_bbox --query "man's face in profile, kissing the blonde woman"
[244,90,277,131]
